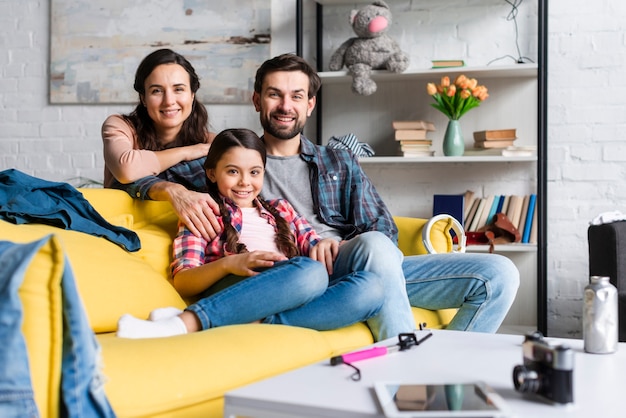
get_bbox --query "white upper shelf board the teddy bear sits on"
[319,64,538,84]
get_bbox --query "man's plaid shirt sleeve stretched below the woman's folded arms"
[113,157,208,200]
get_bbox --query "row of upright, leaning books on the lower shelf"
[463,192,537,244]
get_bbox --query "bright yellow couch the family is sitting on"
[0,189,453,417]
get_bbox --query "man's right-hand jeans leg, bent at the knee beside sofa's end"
[402,254,519,333]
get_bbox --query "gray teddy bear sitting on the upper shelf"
[329,1,409,96]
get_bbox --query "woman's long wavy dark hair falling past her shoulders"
[123,49,209,151]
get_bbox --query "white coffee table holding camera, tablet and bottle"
[224,330,626,418]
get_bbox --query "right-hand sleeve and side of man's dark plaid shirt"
[300,135,398,243]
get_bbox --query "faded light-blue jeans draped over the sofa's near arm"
[0,236,115,417]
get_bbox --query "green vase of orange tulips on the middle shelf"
[426,74,489,156]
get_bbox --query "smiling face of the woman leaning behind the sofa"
[141,64,194,144]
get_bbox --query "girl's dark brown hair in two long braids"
[204,129,300,258]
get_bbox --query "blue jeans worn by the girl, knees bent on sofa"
[187,257,383,331]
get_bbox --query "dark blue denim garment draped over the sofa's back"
[0,169,141,251]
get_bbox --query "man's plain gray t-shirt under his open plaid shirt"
[261,155,341,241]
